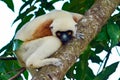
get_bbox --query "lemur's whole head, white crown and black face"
[50,19,76,44]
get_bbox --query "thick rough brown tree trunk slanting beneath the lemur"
[32,0,120,80]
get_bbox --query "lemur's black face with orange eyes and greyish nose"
[56,30,73,44]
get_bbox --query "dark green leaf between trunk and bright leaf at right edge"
[90,25,110,53]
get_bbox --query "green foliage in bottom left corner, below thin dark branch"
[0,60,22,80]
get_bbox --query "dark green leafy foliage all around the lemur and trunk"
[0,0,120,80]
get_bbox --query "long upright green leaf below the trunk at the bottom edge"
[75,47,90,80]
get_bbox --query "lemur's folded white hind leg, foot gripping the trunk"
[25,36,61,68]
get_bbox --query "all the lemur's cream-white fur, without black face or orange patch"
[15,10,82,68]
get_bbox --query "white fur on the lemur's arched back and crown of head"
[15,10,82,41]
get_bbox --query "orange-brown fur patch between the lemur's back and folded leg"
[32,19,53,39]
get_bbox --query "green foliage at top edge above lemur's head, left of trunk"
[62,0,95,14]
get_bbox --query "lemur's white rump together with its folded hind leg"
[16,36,61,68]
